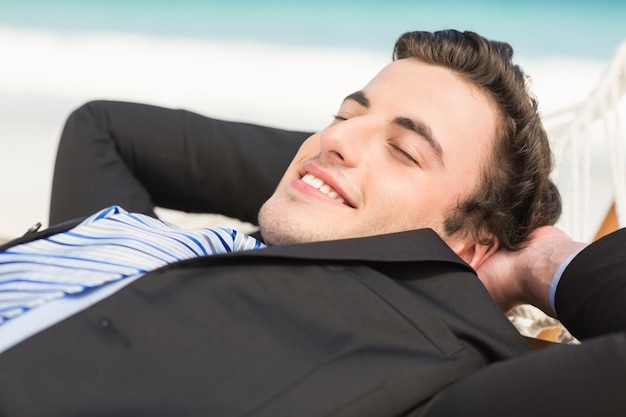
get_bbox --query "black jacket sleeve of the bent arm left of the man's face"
[50,101,309,224]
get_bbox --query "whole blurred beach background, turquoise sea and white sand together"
[0,0,626,238]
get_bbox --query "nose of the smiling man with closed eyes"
[320,118,373,167]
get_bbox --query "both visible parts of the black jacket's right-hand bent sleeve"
[419,229,626,417]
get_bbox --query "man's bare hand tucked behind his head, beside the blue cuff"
[477,226,586,317]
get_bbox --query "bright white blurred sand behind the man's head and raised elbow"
[0,27,607,238]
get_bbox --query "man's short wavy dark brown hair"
[393,30,561,250]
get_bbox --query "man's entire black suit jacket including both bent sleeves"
[0,102,626,417]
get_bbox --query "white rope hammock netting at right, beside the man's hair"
[545,42,626,241]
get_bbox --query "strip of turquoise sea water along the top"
[0,0,626,59]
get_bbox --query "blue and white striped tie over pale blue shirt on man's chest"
[0,206,264,350]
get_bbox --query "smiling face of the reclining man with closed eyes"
[259,59,496,245]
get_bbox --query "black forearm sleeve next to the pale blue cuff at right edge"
[555,229,626,339]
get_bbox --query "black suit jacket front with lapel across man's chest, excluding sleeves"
[0,224,528,417]
